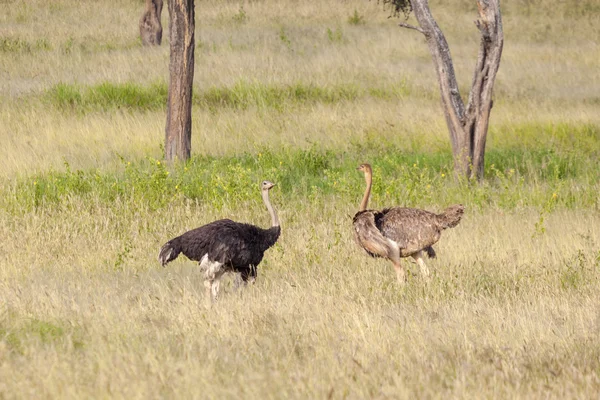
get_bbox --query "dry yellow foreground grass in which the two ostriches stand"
[0,199,600,398]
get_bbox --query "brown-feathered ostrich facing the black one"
[353,164,464,284]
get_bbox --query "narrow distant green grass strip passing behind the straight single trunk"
[45,81,410,113]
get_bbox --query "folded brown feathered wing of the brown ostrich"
[376,207,441,257]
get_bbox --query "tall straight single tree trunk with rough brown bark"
[165,0,194,162]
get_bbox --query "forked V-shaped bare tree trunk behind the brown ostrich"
[400,0,504,180]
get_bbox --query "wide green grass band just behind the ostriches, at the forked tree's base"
[4,125,600,217]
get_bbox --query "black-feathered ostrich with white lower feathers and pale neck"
[158,181,281,303]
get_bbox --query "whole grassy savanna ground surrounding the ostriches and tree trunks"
[0,0,600,399]
